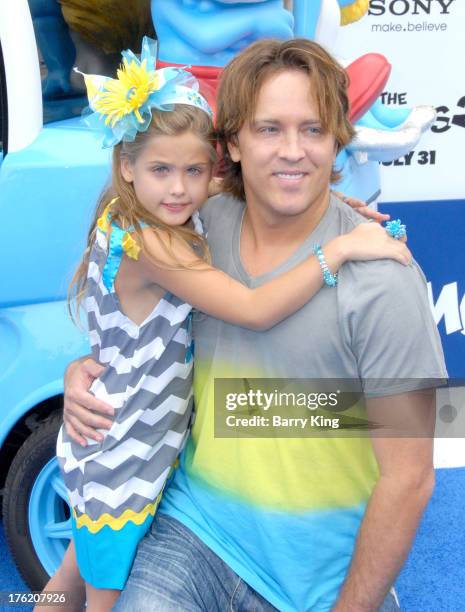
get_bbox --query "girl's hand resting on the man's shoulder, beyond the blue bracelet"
[336,223,412,266]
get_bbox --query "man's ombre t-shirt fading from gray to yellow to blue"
[160,195,446,612]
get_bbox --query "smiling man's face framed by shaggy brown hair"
[228,70,336,222]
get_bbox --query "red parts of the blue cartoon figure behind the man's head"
[157,53,391,123]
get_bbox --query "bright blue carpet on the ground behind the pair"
[0,468,465,612]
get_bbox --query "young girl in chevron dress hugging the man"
[47,41,408,612]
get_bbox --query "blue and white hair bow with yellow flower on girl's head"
[75,36,213,148]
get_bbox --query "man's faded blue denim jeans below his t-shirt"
[113,514,399,612]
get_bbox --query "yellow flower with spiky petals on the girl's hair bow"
[95,58,159,127]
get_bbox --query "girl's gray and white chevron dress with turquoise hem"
[57,214,193,589]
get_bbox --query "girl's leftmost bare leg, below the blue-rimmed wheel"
[34,540,86,612]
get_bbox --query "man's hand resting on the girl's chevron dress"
[63,358,114,446]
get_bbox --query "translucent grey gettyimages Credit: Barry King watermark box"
[214,378,454,438]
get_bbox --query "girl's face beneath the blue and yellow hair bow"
[121,132,213,225]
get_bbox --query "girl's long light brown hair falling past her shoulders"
[68,104,216,322]
